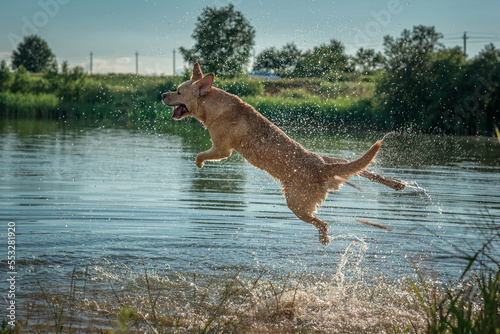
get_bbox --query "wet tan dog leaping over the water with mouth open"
[161,63,405,245]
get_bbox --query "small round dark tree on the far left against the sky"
[12,35,55,73]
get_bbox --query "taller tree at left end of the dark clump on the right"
[376,26,443,128]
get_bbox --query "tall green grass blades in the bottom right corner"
[402,217,500,334]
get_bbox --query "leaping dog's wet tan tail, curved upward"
[326,139,383,190]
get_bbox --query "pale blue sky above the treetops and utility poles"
[0,0,500,75]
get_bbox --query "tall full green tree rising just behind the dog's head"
[179,4,255,77]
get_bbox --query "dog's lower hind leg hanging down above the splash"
[283,187,330,246]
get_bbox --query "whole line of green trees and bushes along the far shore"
[0,4,500,135]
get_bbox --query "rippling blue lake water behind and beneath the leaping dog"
[0,120,500,332]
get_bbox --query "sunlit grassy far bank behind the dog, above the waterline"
[0,73,390,132]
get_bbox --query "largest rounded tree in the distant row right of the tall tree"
[294,39,348,78]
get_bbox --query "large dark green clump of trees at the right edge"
[375,26,500,135]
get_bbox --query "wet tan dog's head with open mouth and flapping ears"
[161,63,214,120]
